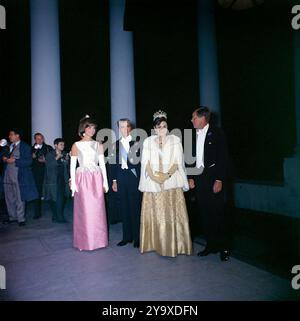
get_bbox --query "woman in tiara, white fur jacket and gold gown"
[139,111,192,257]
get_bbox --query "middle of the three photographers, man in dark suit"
[32,133,53,219]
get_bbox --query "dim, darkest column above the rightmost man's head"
[197,0,220,118]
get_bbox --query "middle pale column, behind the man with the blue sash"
[109,0,136,137]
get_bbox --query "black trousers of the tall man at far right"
[195,171,228,251]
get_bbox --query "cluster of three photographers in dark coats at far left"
[0,128,70,226]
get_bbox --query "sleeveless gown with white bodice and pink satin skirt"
[73,141,108,251]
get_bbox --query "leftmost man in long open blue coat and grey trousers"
[2,129,38,226]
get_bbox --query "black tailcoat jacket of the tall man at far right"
[186,124,228,181]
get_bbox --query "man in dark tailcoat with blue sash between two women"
[110,118,142,247]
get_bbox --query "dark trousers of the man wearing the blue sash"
[117,169,142,242]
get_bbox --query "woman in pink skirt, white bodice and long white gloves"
[70,116,108,251]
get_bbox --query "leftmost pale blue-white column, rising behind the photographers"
[30,0,62,145]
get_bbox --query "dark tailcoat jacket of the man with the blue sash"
[109,140,141,182]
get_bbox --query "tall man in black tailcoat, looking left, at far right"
[187,107,229,261]
